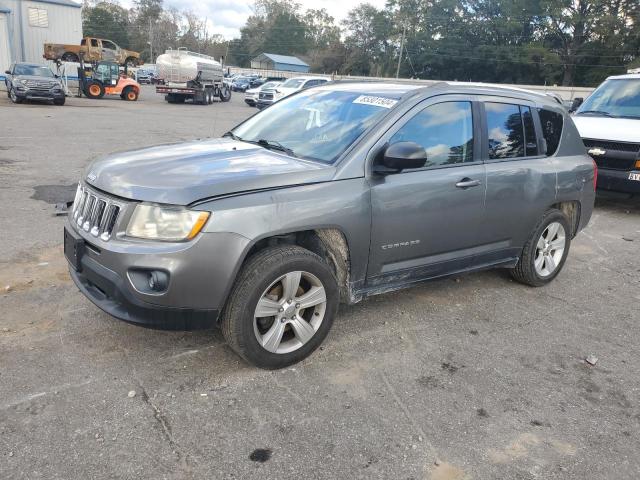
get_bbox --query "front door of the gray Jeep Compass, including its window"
[367,95,486,290]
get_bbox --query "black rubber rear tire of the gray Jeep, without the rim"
[511,208,572,287]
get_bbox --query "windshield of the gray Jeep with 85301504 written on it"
[232,89,397,163]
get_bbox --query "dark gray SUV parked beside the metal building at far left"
[4,62,65,105]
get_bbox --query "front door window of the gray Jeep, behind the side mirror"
[389,102,473,167]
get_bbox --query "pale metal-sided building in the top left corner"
[0,0,82,71]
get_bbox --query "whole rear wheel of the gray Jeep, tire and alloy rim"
[511,208,571,287]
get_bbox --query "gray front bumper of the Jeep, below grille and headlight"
[65,220,249,330]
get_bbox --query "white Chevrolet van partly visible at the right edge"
[573,74,640,194]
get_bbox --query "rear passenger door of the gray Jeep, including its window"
[474,96,557,266]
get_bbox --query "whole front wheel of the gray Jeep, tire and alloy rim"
[221,245,339,370]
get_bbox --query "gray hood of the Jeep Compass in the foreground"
[85,138,335,205]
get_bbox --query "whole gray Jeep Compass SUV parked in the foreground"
[64,83,596,368]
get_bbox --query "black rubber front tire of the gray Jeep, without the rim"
[221,245,340,370]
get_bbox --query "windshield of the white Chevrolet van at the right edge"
[576,78,640,119]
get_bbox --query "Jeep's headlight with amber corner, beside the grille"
[126,203,211,242]
